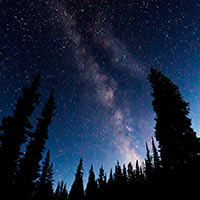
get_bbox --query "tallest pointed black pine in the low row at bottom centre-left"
[69,158,84,200]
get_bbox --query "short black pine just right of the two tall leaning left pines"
[35,151,53,200]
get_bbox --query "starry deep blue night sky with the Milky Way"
[0,0,200,187]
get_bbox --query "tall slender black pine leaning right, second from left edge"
[17,90,55,199]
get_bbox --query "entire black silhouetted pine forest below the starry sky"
[0,68,200,200]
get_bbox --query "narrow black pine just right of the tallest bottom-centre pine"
[85,166,97,200]
